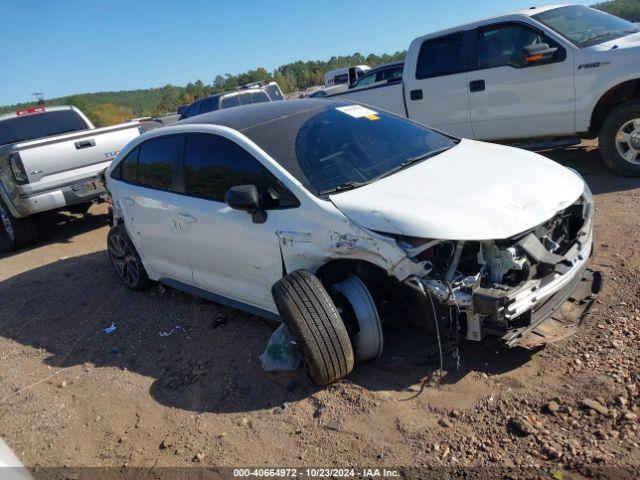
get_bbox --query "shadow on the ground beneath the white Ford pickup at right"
[537,142,640,195]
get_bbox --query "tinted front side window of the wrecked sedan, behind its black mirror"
[184,135,299,208]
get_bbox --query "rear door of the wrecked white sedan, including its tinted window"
[117,135,193,284]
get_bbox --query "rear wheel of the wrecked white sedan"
[107,225,153,291]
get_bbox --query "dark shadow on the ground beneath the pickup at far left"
[0,205,109,260]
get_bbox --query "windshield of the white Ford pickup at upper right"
[533,5,640,48]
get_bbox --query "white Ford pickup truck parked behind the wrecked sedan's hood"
[330,5,640,176]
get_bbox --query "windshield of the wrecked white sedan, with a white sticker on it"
[243,102,457,196]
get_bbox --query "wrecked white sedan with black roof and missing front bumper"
[106,99,599,384]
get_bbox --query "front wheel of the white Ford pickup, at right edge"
[599,100,640,177]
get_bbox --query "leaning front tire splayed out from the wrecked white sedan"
[271,270,354,385]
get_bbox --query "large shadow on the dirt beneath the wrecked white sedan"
[0,251,528,412]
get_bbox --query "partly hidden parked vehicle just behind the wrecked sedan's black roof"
[178,82,284,120]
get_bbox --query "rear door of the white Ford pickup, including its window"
[404,32,473,138]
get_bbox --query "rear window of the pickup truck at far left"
[0,110,87,145]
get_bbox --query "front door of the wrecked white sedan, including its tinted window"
[175,133,295,312]
